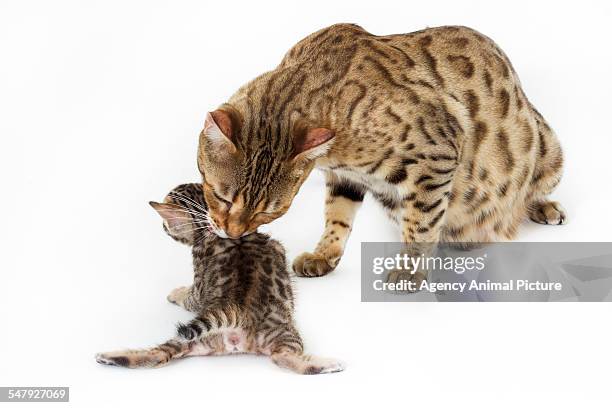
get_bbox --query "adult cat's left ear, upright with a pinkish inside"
[202,108,240,153]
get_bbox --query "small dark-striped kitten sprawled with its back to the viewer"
[96,184,344,374]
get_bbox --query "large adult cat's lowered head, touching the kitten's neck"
[198,105,334,238]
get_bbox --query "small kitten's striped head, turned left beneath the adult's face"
[149,183,210,245]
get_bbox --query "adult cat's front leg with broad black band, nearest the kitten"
[293,171,365,277]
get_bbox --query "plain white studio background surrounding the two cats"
[0,0,612,407]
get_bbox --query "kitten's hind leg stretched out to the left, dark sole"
[96,337,191,368]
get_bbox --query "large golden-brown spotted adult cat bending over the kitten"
[198,24,566,281]
